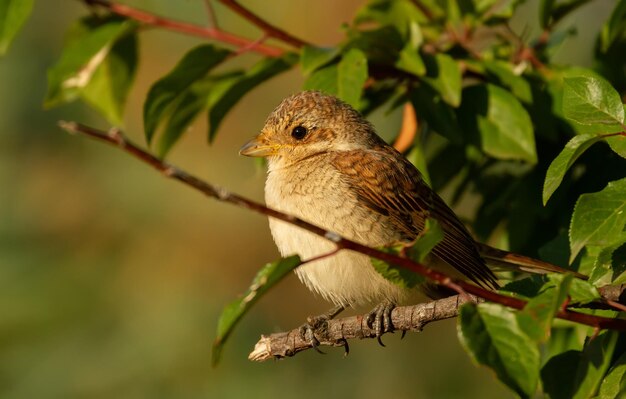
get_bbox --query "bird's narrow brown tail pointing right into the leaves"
[476,243,589,280]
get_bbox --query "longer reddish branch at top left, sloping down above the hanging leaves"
[82,0,285,57]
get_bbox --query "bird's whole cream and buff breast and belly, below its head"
[265,159,405,306]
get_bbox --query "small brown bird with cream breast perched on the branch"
[240,91,580,342]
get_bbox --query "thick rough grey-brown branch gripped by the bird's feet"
[248,295,472,362]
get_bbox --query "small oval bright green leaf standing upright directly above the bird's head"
[337,48,367,108]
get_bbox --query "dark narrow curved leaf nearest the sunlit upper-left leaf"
[143,44,232,142]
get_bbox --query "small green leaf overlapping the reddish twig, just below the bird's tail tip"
[517,274,574,343]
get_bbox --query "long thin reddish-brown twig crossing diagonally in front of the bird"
[59,122,626,331]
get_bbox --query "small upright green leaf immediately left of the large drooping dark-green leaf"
[423,53,461,108]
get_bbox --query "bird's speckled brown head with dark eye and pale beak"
[239,91,381,165]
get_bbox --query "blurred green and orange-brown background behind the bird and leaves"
[0,0,614,398]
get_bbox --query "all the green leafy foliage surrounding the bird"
[0,0,626,398]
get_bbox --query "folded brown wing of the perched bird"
[332,147,498,288]
